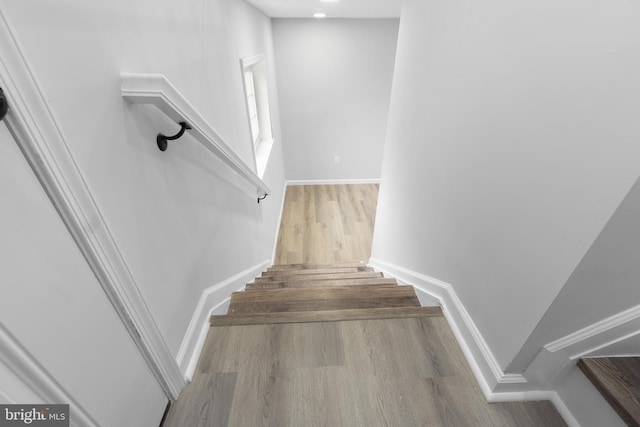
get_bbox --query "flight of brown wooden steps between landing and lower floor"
[210,263,442,326]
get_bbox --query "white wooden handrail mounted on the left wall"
[120,73,271,203]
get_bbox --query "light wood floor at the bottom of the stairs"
[275,184,378,264]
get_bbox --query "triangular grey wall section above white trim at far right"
[510,176,640,371]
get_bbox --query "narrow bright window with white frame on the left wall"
[240,55,273,178]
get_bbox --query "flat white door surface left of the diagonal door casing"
[0,123,167,426]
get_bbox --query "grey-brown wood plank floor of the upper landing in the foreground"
[165,316,565,427]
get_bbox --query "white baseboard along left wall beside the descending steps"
[176,260,271,381]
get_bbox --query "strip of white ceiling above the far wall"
[247,0,402,18]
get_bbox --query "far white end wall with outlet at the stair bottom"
[273,19,398,180]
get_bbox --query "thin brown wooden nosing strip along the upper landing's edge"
[210,307,442,326]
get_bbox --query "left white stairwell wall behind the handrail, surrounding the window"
[0,0,284,425]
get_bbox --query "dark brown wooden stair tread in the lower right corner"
[578,357,640,426]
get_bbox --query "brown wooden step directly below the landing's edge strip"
[228,286,420,314]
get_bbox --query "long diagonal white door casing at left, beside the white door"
[0,9,185,399]
